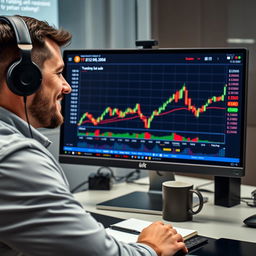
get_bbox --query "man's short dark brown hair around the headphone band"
[0,15,72,89]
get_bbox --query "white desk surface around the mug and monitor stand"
[75,175,256,243]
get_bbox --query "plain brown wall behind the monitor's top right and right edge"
[151,0,256,185]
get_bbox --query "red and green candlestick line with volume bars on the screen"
[78,80,227,143]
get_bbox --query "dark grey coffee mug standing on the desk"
[162,181,203,221]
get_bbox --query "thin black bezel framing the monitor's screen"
[59,48,248,177]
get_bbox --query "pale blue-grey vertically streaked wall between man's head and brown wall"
[59,0,151,49]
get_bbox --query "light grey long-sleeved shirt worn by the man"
[0,107,156,256]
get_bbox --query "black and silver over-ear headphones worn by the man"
[0,16,42,97]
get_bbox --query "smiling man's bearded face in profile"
[28,40,71,128]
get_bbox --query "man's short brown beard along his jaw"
[28,90,63,128]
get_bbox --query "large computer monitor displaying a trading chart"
[59,48,247,210]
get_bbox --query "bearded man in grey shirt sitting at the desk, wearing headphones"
[0,17,187,256]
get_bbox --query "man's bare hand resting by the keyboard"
[137,221,188,256]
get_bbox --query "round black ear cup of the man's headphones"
[7,59,42,96]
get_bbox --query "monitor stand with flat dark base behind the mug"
[96,171,207,215]
